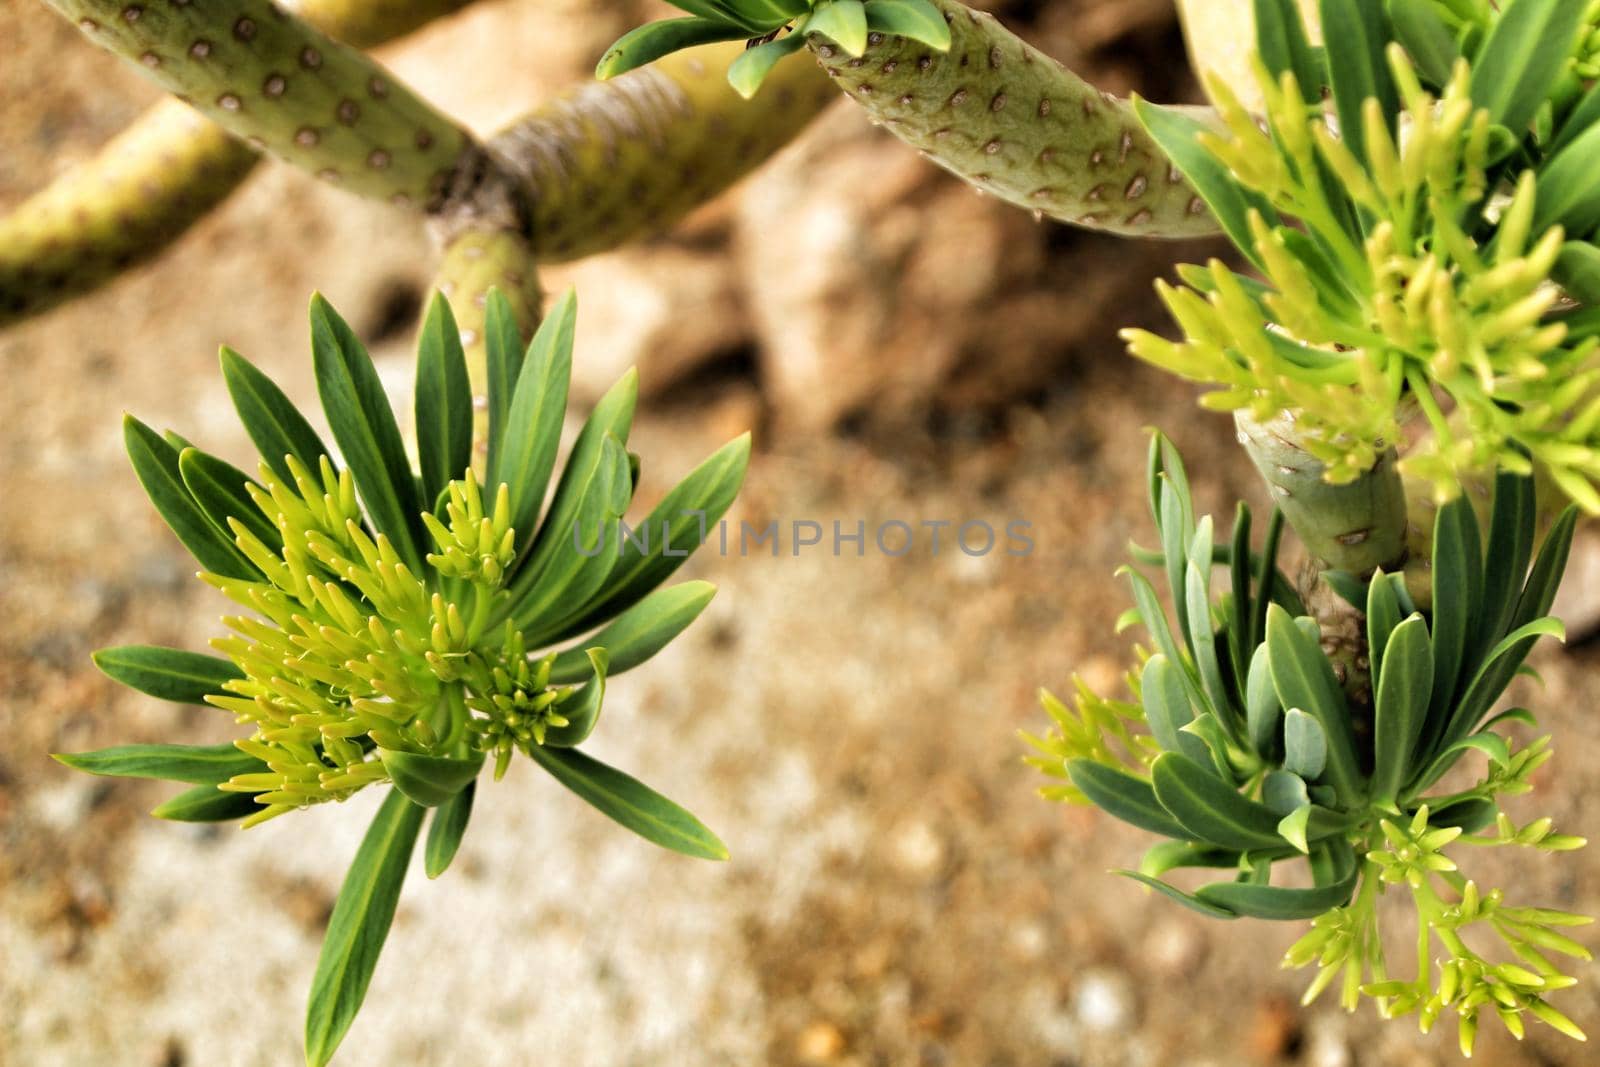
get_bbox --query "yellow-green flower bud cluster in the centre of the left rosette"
[205,456,574,825]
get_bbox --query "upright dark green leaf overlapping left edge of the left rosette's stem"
[416,293,467,501]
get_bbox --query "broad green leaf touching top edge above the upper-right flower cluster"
[1469,0,1589,138]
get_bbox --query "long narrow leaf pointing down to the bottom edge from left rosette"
[306,790,422,1067]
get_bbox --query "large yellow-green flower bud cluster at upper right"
[1125,45,1600,510]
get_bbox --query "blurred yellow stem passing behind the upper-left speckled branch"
[0,0,469,328]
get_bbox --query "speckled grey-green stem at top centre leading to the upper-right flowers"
[810,0,1218,237]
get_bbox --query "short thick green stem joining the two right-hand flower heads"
[1234,411,1406,577]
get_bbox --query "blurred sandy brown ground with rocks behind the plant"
[0,0,1600,1067]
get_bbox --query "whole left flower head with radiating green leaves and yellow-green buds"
[58,290,749,1064]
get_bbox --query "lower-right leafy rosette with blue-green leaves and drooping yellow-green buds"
[1029,435,1590,1054]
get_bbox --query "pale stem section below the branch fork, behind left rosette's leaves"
[434,229,544,460]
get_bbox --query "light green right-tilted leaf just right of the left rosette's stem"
[488,290,585,563]
